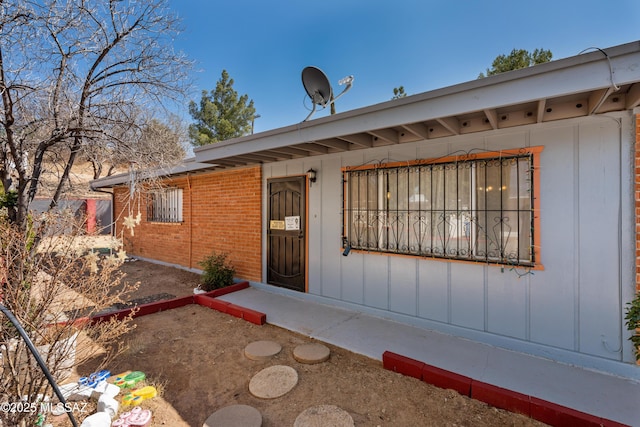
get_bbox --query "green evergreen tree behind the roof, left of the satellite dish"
[189,70,257,147]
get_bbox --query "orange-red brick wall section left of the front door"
[114,167,262,281]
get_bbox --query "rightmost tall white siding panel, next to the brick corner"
[576,121,620,357]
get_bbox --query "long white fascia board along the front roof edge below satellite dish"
[194,42,640,163]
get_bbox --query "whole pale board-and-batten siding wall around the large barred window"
[263,112,636,366]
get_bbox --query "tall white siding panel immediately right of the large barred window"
[530,126,578,349]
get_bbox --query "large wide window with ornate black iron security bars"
[343,152,536,266]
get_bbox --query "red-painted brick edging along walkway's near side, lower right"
[382,351,629,427]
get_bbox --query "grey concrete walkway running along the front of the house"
[219,287,640,426]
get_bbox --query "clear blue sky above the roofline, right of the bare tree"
[169,0,640,132]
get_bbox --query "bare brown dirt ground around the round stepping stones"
[48,261,544,427]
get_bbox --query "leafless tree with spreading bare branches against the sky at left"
[0,0,191,231]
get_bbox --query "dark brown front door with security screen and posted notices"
[267,176,306,292]
